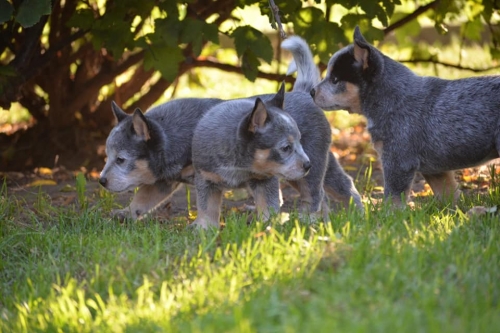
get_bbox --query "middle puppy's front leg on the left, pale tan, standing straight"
[192,172,222,229]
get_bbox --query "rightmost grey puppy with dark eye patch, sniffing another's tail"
[311,27,500,205]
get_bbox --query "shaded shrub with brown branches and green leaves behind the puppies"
[0,0,500,129]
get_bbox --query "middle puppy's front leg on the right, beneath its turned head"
[249,177,280,221]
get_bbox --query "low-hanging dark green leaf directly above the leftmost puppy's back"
[144,45,184,82]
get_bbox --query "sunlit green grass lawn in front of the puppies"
[0,172,500,332]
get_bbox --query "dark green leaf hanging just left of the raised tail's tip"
[231,25,273,63]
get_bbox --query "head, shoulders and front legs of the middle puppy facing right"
[193,84,312,228]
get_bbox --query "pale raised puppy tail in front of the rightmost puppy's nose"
[281,36,321,93]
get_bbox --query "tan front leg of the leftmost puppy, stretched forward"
[111,181,181,220]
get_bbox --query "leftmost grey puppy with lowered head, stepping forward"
[99,98,222,219]
